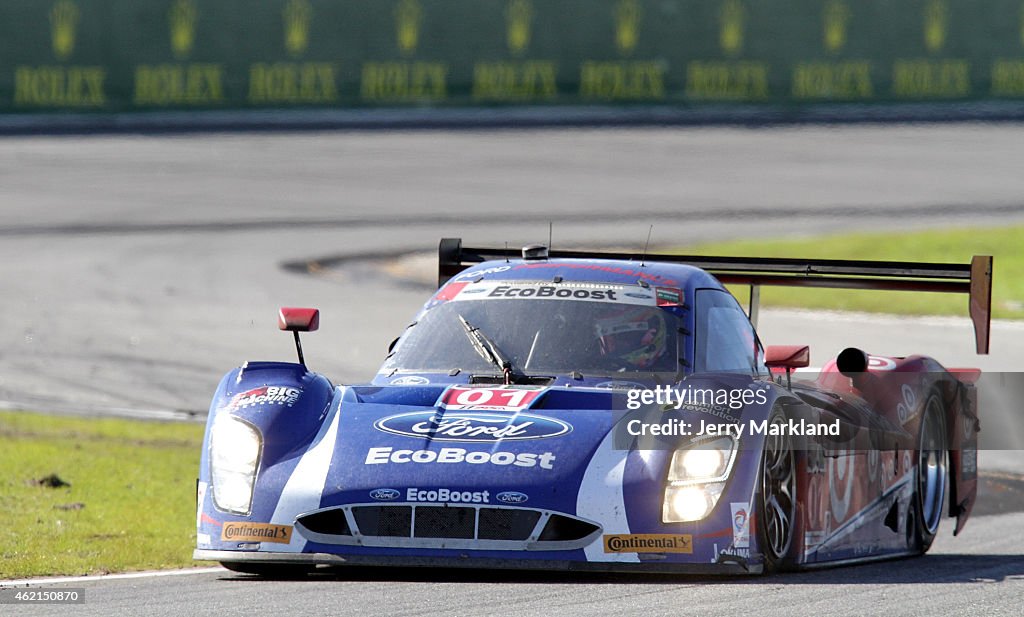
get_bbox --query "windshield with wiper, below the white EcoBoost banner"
[382,288,680,383]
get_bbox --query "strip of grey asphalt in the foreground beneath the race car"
[4,514,1024,617]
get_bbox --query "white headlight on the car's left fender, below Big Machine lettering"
[210,415,263,515]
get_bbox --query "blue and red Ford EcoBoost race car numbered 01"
[194,238,992,576]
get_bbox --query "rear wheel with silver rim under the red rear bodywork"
[907,394,947,555]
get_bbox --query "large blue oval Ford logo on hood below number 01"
[374,411,572,442]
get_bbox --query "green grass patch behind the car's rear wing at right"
[678,226,1024,319]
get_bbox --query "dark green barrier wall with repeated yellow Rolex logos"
[0,0,1024,113]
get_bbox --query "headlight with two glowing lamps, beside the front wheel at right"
[662,437,736,523]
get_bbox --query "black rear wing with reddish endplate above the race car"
[437,237,992,354]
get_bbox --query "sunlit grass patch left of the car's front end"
[0,411,203,579]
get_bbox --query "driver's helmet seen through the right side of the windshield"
[594,307,668,368]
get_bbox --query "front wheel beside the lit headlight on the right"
[757,411,801,572]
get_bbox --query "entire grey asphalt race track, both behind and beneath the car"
[0,124,1024,616]
